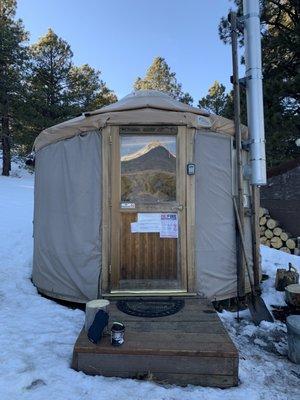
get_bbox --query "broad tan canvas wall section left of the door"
[32,131,102,301]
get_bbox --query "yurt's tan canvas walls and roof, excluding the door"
[32,91,252,302]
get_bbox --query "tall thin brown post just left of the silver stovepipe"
[229,12,245,297]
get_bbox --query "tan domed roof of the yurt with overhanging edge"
[34,90,247,151]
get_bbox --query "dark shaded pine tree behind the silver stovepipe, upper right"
[219,0,300,165]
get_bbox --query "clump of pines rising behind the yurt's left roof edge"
[16,29,117,153]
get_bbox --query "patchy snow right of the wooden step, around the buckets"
[220,246,300,399]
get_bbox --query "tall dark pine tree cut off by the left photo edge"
[0,0,27,176]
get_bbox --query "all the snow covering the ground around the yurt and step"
[0,164,300,400]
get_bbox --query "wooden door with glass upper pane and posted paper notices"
[110,127,187,293]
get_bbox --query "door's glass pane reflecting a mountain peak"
[121,135,176,203]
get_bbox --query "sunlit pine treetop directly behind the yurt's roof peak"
[133,57,193,104]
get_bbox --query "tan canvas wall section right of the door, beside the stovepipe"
[195,130,252,299]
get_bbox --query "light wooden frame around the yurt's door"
[98,125,196,297]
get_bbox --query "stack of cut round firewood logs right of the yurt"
[259,207,296,253]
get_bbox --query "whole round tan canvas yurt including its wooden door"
[32,90,252,303]
